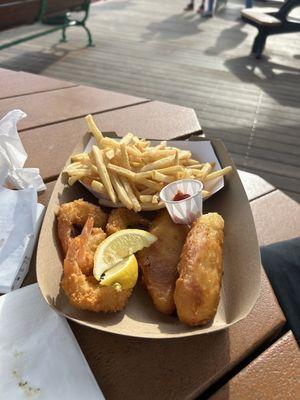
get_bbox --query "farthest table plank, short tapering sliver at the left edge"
[0,72,76,99]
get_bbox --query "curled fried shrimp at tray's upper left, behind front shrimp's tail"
[57,199,107,254]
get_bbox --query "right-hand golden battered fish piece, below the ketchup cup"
[174,213,224,326]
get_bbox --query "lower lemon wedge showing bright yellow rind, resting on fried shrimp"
[100,254,138,289]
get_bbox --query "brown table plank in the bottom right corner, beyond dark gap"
[210,331,300,400]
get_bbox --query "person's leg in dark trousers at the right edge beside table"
[261,237,300,344]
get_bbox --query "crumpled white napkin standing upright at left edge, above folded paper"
[0,110,46,191]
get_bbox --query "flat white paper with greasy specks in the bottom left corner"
[0,284,104,400]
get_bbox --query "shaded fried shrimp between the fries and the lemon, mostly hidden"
[106,208,150,235]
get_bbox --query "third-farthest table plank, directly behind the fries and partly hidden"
[21,102,200,179]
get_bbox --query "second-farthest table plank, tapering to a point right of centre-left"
[0,86,146,130]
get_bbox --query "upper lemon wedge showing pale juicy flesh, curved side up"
[93,229,157,281]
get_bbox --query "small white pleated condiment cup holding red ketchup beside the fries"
[160,179,203,224]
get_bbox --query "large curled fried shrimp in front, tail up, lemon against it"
[61,217,132,312]
